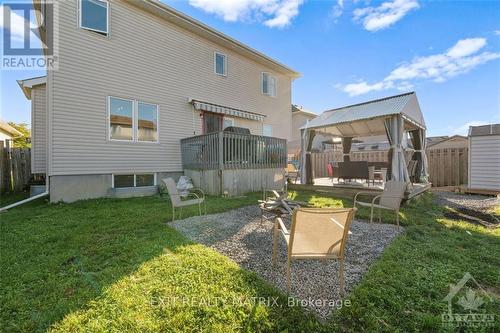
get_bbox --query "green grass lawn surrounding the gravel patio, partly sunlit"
[0,189,500,332]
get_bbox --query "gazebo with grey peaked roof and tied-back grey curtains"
[301,92,428,191]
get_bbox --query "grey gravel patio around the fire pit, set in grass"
[169,206,403,318]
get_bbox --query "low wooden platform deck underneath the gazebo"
[288,178,431,200]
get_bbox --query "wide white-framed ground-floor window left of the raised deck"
[108,97,158,142]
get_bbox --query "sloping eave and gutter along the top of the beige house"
[128,0,300,78]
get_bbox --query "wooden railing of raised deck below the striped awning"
[181,132,287,170]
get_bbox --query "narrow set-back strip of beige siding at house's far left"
[31,85,47,173]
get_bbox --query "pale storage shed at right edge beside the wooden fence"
[468,124,500,193]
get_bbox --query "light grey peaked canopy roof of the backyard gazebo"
[302,92,425,136]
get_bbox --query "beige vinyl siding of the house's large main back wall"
[49,0,291,175]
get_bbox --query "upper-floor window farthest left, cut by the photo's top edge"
[80,0,109,35]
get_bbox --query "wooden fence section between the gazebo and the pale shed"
[427,148,469,186]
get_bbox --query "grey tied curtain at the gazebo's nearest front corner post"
[385,115,410,182]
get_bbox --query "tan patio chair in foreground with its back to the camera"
[273,208,356,295]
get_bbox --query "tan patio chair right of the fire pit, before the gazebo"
[354,180,408,227]
